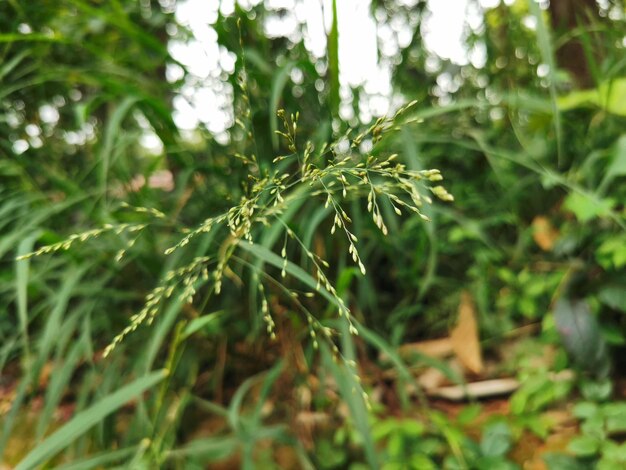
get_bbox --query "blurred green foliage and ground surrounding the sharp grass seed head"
[0,0,626,469]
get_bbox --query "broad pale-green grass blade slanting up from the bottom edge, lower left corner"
[15,370,168,470]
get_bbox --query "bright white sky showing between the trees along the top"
[163,0,486,136]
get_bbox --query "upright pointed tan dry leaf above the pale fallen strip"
[450,291,483,374]
